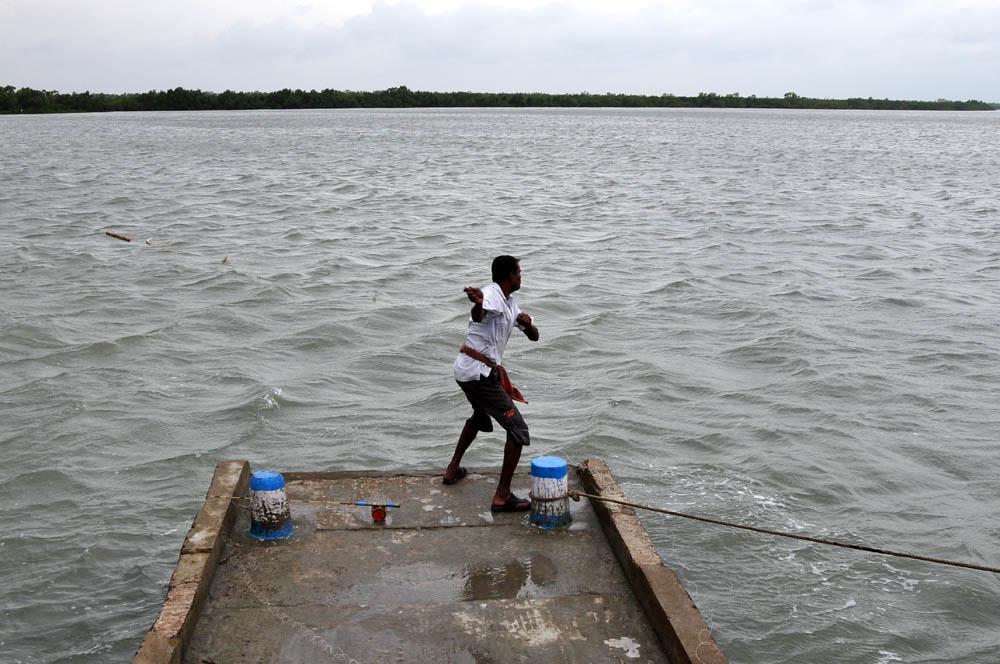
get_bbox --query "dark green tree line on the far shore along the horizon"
[0,85,1000,113]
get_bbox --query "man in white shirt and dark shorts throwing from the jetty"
[443,256,538,512]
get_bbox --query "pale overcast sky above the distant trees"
[0,0,1000,101]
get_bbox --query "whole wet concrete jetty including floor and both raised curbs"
[134,461,725,664]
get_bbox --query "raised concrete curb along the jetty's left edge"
[132,461,250,664]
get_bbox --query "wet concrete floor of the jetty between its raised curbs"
[184,472,667,664]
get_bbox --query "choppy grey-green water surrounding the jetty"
[0,110,1000,664]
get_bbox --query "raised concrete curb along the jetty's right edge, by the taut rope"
[577,459,726,664]
